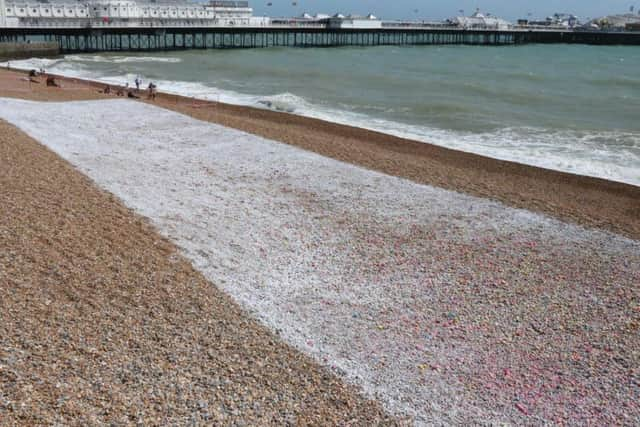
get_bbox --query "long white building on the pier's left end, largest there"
[0,0,269,28]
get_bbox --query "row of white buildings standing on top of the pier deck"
[0,0,504,30]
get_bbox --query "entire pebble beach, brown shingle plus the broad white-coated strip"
[0,70,640,425]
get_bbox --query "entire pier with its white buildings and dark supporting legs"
[0,0,640,53]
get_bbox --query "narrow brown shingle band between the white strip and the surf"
[0,70,640,239]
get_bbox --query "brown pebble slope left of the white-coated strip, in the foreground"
[0,116,397,425]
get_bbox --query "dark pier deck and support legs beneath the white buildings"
[0,26,640,53]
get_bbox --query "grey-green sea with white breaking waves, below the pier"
[5,45,640,186]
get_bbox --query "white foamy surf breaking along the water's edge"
[2,55,640,185]
